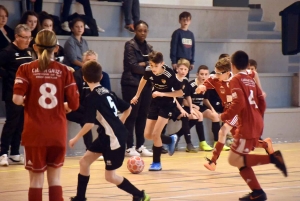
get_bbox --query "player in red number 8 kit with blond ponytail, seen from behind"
[13,30,79,201]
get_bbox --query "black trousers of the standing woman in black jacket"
[121,84,152,148]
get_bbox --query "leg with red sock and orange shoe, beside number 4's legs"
[204,123,232,171]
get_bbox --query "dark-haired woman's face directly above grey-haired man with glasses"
[20,11,40,47]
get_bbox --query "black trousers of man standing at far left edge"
[0,100,24,156]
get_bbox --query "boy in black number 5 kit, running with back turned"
[69,61,150,201]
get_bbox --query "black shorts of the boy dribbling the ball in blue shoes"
[148,98,176,120]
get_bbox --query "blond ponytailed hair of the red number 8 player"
[35,29,57,71]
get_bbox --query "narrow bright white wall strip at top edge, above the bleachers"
[140,0,213,6]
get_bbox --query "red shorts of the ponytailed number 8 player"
[24,146,66,172]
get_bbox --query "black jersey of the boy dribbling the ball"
[144,65,182,100]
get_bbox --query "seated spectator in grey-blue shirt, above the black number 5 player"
[63,18,89,70]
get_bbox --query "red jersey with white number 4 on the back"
[221,72,266,139]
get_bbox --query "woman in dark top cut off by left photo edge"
[0,5,15,50]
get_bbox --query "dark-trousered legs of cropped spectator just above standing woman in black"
[123,0,140,33]
